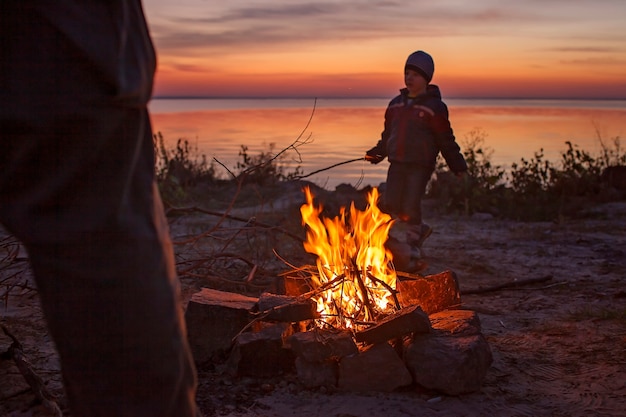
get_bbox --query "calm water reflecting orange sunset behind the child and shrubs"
[150,98,626,189]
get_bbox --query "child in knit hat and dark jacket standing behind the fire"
[365,51,467,259]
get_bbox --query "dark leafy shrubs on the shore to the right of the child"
[428,129,626,220]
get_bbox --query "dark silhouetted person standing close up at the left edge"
[0,0,199,417]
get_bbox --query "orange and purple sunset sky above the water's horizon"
[143,0,626,99]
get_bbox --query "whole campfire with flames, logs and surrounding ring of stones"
[185,188,492,395]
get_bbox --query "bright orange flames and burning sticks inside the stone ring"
[300,187,396,329]
